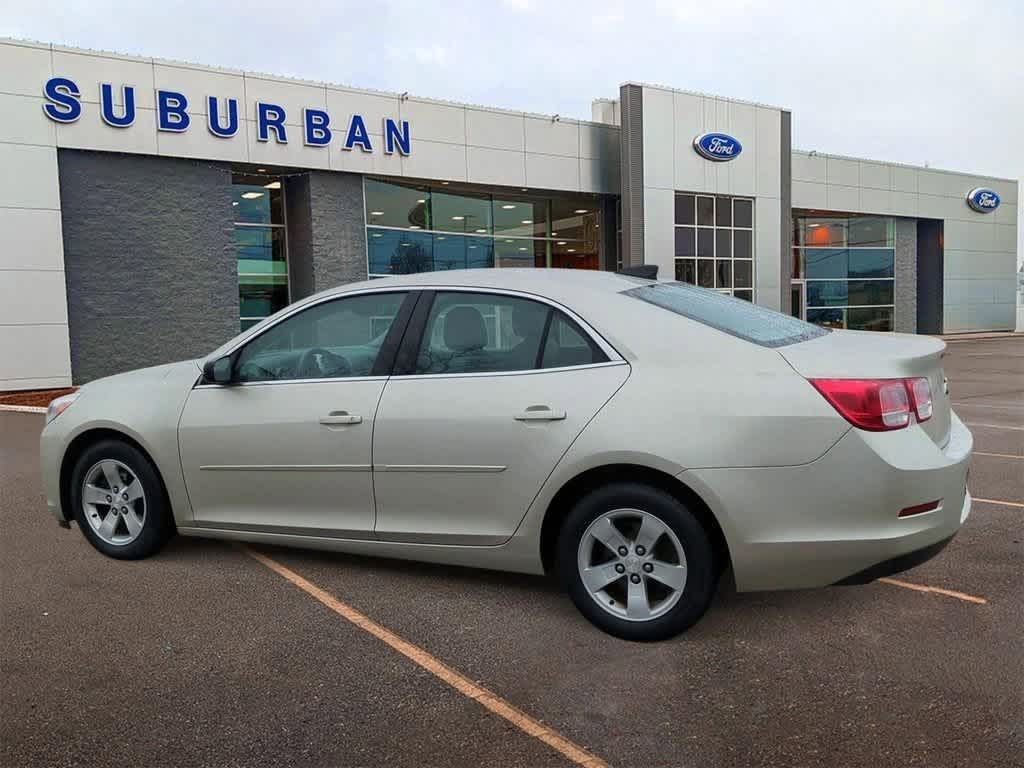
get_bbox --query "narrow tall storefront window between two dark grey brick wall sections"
[231,173,290,331]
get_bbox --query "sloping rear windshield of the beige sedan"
[623,283,828,347]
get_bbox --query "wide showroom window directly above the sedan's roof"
[365,178,601,276]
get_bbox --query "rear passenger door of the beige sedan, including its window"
[374,290,630,545]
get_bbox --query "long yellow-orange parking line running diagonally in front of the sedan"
[241,545,607,768]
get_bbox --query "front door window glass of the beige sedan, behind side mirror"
[236,293,407,382]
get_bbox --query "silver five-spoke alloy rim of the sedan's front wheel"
[82,459,146,547]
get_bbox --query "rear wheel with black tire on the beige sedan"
[558,482,719,641]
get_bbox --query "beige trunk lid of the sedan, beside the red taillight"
[776,331,949,445]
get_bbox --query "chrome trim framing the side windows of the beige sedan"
[208,284,626,376]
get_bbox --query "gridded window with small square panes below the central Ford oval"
[675,193,754,300]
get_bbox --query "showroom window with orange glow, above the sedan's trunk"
[793,214,896,331]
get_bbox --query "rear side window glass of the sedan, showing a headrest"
[415,291,606,374]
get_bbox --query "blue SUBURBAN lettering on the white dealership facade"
[43,77,412,155]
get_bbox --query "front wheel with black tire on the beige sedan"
[69,439,174,560]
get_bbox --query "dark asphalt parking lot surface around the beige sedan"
[0,337,1024,768]
